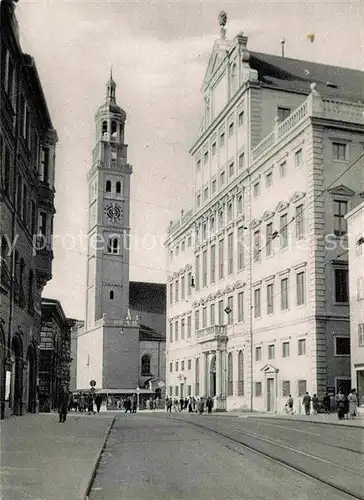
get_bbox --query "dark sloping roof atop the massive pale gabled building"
[249,51,364,101]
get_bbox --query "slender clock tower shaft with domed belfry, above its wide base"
[85,73,132,330]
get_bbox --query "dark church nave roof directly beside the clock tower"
[129,281,166,314]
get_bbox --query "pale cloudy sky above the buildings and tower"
[16,0,364,319]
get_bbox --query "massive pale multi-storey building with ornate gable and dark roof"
[166,17,364,411]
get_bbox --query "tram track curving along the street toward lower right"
[172,416,364,500]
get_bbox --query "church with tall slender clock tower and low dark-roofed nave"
[76,75,165,397]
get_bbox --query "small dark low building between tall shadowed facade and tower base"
[39,299,76,412]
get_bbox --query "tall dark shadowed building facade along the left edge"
[0,0,58,418]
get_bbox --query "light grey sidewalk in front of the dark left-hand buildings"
[0,413,114,500]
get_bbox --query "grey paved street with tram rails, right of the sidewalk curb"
[90,413,364,500]
